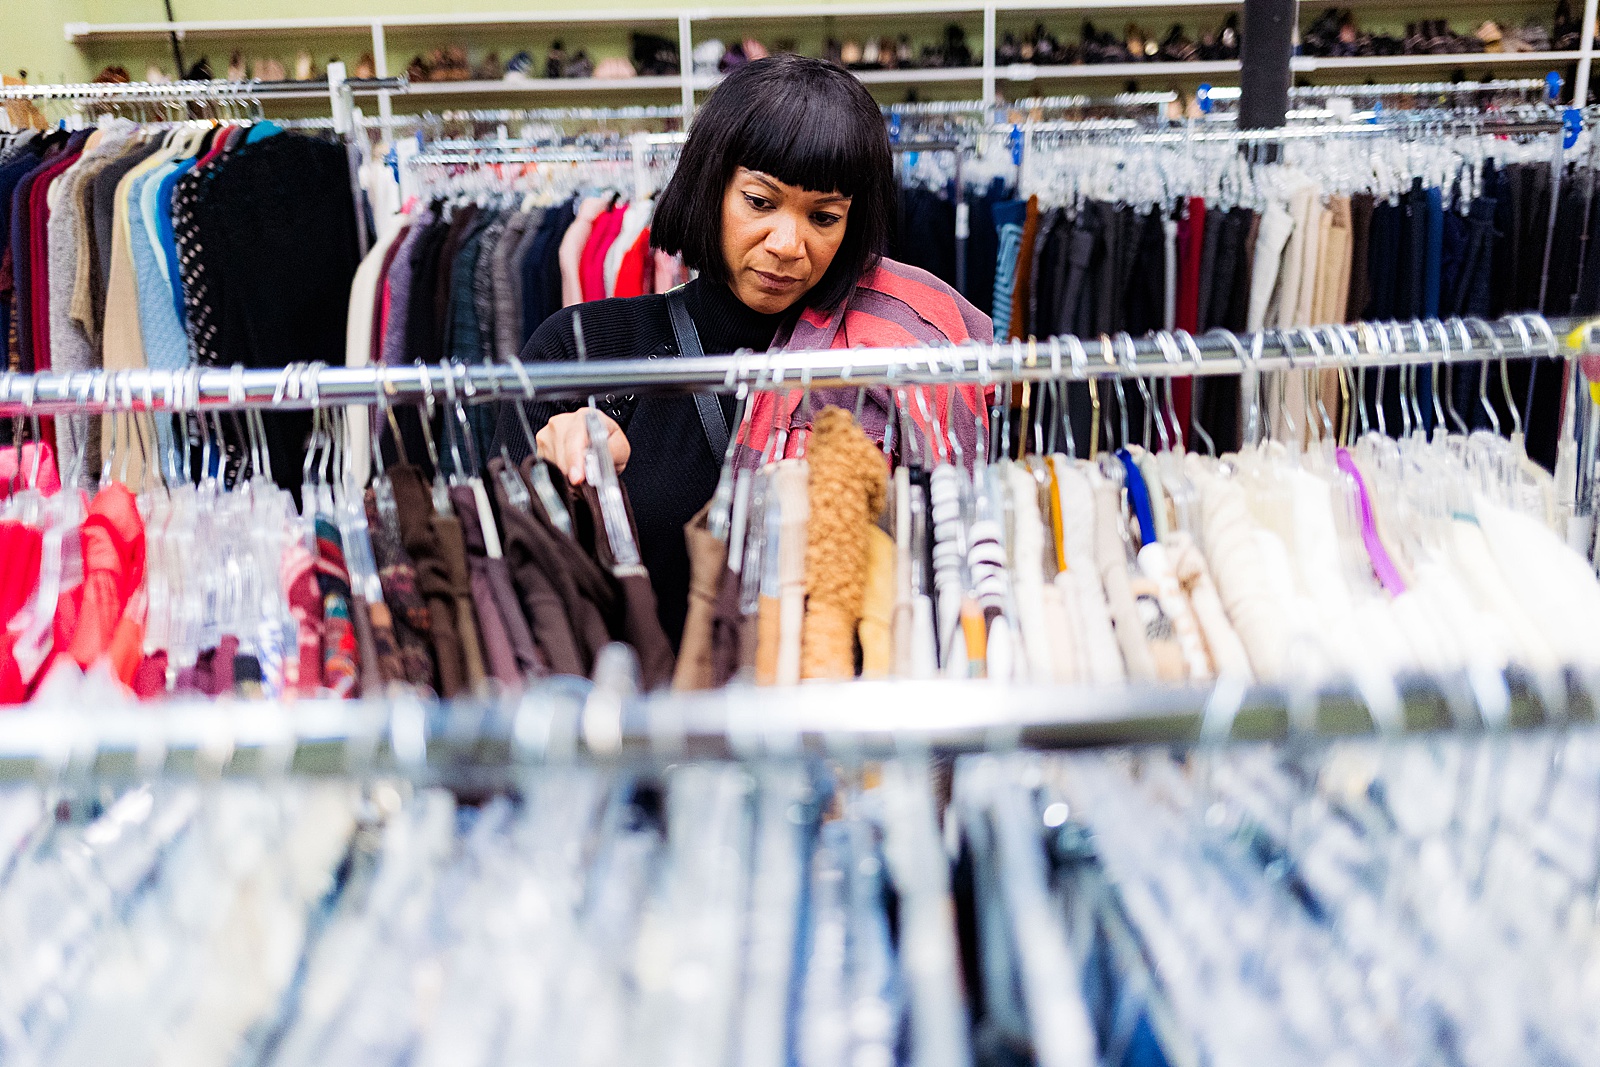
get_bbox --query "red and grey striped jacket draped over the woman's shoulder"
[736,259,994,469]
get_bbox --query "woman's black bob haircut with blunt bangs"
[650,54,899,310]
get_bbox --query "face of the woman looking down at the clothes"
[722,166,850,315]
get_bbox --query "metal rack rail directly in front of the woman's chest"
[0,315,1574,418]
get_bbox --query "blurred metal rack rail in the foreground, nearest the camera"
[0,670,1580,785]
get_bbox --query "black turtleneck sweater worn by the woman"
[494,278,792,648]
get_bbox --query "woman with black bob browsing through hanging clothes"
[496,54,994,646]
